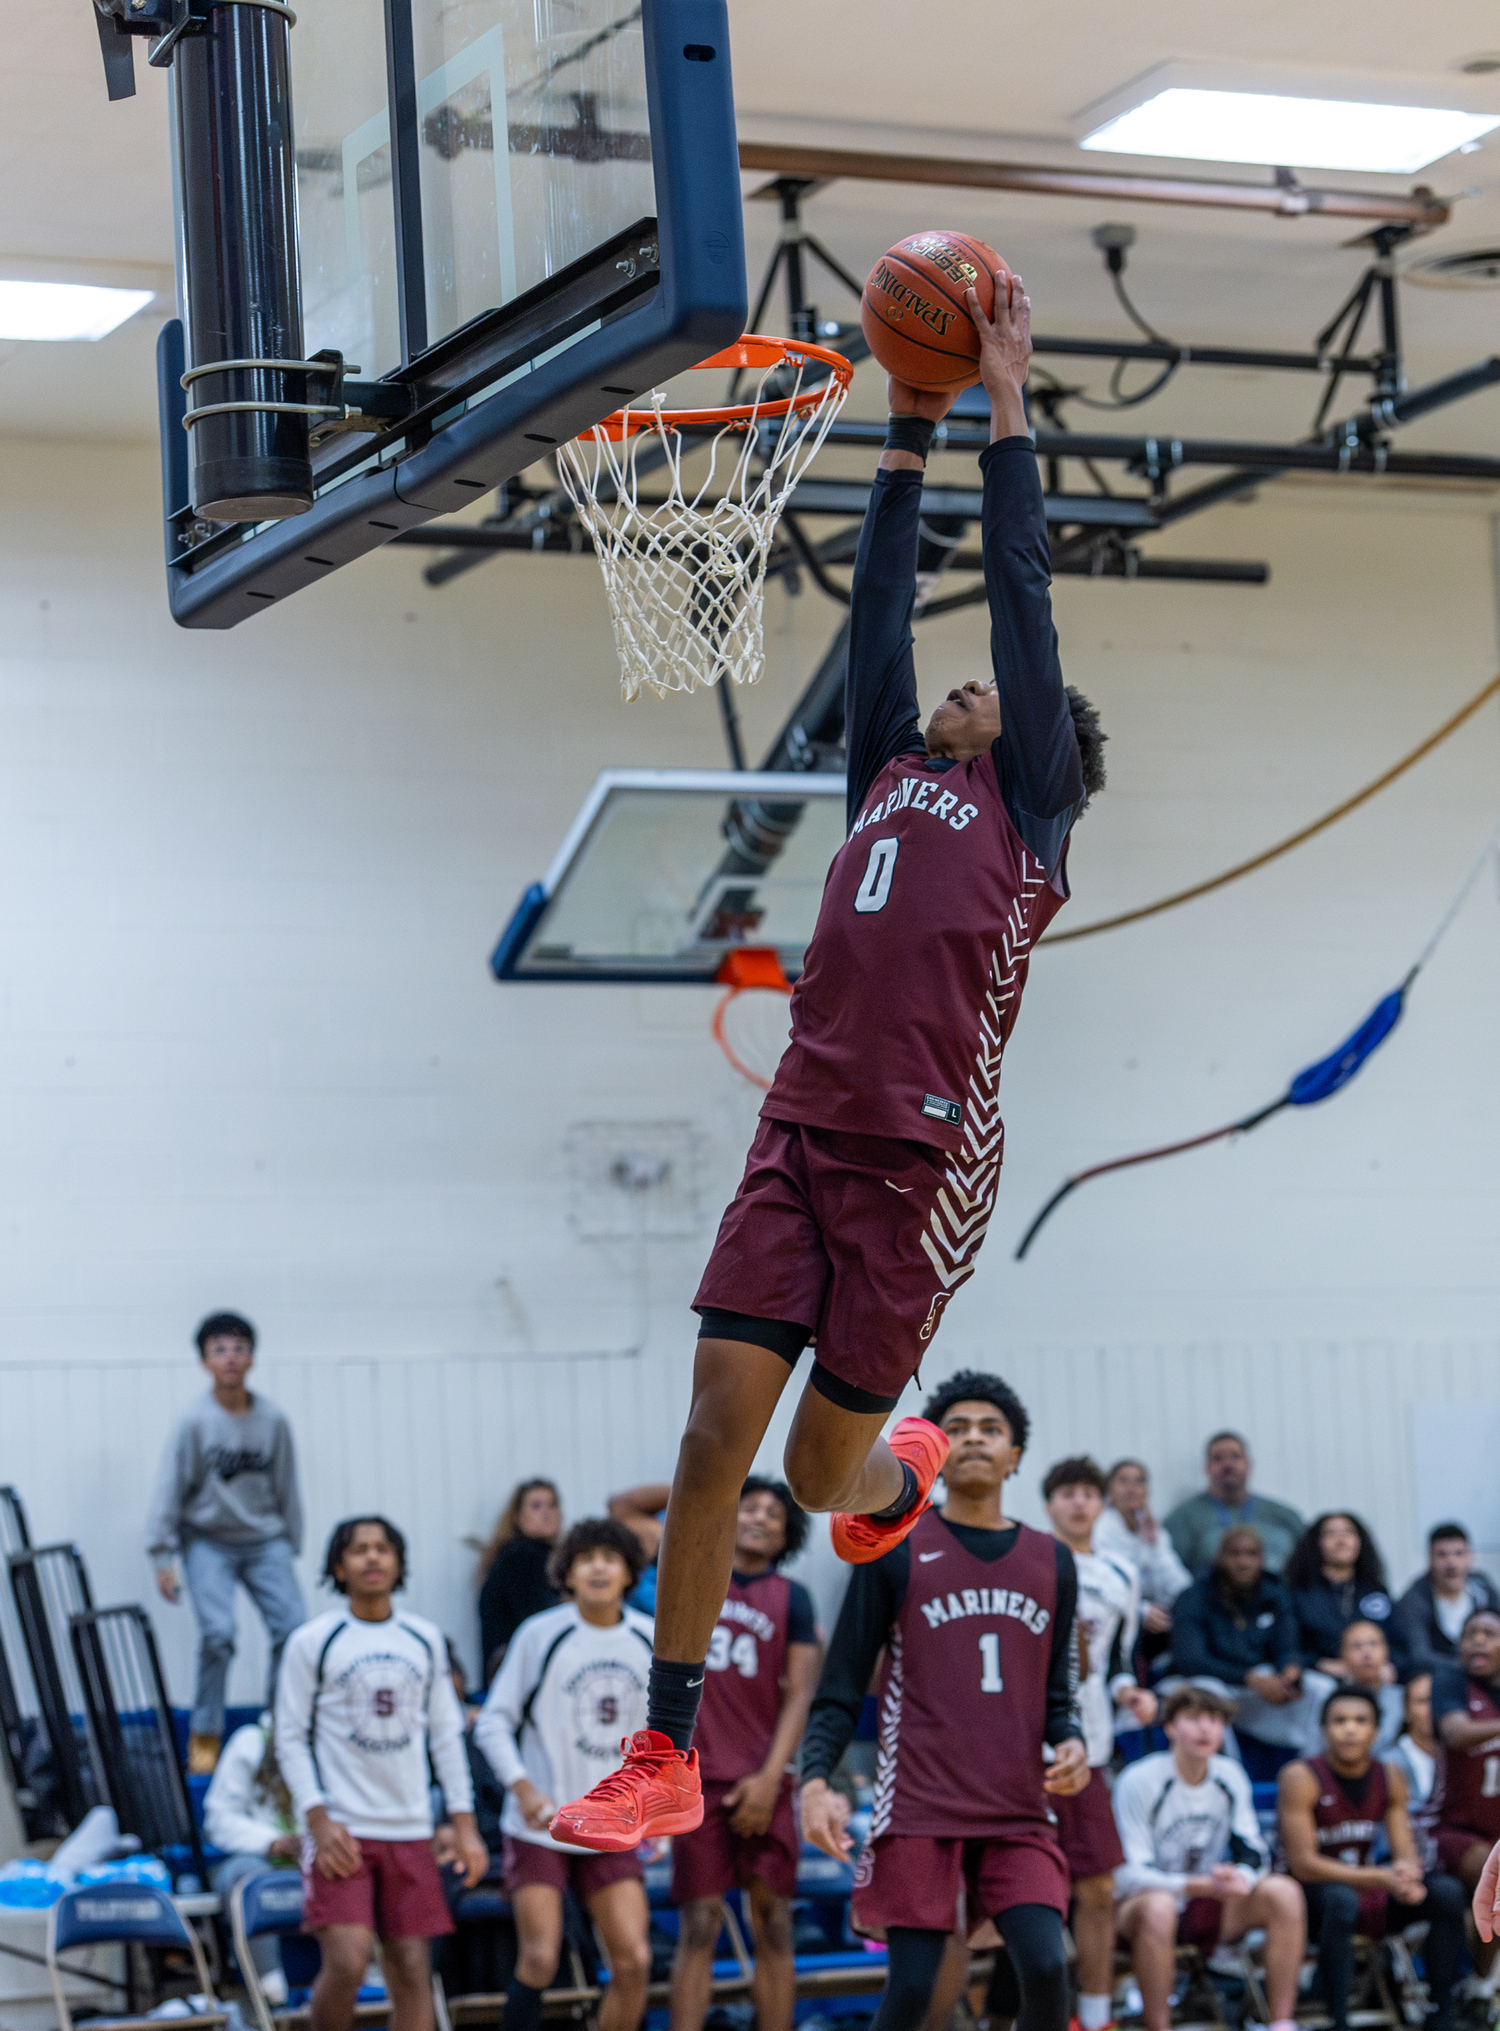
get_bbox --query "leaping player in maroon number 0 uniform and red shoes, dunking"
[556,270,1104,1848]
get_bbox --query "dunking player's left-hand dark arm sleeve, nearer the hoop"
[844,473,926,825]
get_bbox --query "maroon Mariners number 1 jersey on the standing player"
[871,1509,1058,1840]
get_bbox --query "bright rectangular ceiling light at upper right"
[1080,85,1500,175]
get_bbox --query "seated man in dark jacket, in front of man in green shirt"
[1171,1523,1307,1775]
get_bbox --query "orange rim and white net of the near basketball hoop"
[558,337,855,699]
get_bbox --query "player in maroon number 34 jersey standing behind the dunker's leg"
[670,1475,822,2031]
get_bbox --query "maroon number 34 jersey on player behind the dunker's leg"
[692,1572,818,1783]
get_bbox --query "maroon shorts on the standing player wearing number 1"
[850,1826,1068,1940]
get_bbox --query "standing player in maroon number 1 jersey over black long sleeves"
[802,1373,1088,2031]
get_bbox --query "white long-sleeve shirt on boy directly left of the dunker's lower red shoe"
[475,1600,652,1854]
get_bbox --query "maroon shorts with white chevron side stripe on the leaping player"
[692,1121,999,1412]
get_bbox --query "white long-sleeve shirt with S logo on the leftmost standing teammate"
[276,1607,473,1840]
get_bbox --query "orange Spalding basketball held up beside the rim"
[859,232,1009,392]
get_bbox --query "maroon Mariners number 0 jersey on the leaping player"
[761,749,1066,1161]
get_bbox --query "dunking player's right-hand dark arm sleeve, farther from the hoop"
[978,437,1084,873]
